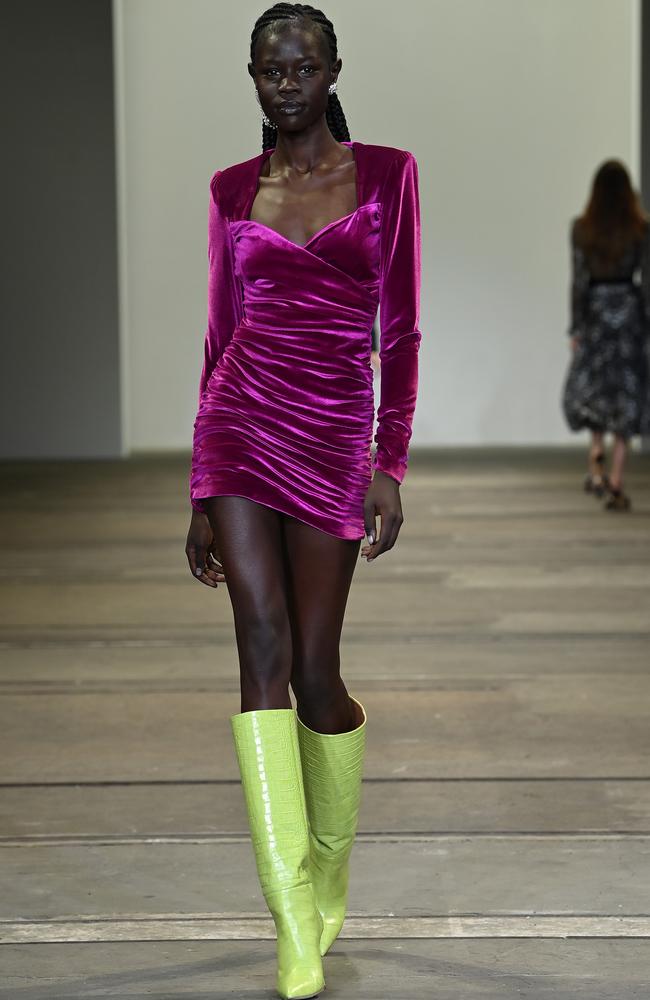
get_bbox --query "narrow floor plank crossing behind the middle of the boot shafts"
[5,779,650,843]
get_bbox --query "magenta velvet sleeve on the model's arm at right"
[374,150,421,483]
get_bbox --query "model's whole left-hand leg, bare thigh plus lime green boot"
[205,497,324,997]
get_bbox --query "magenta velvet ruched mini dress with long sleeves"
[190,142,421,539]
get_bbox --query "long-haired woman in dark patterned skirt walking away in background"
[563,160,650,511]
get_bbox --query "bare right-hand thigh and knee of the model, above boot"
[284,518,360,733]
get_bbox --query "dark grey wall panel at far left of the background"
[0,0,121,458]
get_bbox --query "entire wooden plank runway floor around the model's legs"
[0,450,650,1000]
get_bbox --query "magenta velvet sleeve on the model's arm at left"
[199,170,242,403]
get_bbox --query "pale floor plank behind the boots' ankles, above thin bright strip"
[0,835,650,920]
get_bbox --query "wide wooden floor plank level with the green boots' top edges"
[0,684,650,783]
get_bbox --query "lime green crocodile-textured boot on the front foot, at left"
[230,708,325,1000]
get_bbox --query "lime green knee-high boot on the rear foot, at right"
[298,699,366,955]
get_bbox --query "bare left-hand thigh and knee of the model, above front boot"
[205,497,292,712]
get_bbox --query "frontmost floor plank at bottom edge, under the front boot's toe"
[0,940,650,1000]
